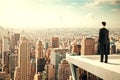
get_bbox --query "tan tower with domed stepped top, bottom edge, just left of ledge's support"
[58,59,71,80]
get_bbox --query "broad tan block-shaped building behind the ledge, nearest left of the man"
[81,38,95,55]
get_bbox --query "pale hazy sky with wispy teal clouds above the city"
[0,0,120,29]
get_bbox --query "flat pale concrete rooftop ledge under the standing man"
[66,54,120,80]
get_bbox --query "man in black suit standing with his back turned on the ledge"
[98,22,109,63]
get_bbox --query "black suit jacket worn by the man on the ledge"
[98,28,109,44]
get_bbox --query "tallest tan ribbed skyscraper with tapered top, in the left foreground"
[18,37,31,80]
